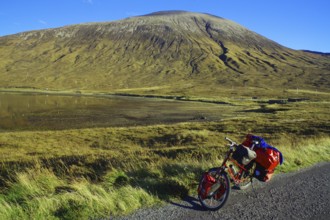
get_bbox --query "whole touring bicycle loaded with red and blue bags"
[197,134,283,210]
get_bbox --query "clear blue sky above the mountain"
[0,0,330,52]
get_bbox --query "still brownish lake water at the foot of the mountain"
[0,93,229,131]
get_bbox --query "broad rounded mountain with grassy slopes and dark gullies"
[0,11,330,93]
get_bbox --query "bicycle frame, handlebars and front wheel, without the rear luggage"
[197,137,258,210]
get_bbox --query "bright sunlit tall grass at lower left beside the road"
[0,168,159,219]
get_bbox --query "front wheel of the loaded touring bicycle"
[198,168,230,210]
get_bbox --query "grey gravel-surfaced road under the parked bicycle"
[118,163,330,220]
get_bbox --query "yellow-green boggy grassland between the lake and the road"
[0,90,330,219]
